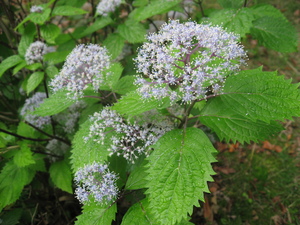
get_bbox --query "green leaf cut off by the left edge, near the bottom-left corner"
[0,161,35,211]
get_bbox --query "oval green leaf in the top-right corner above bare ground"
[251,16,298,52]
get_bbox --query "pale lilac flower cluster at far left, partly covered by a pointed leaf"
[20,92,51,129]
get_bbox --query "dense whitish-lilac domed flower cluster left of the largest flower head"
[50,44,110,100]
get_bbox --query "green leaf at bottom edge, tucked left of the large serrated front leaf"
[121,198,158,225]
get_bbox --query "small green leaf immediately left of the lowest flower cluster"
[49,161,73,194]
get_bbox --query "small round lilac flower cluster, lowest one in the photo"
[74,163,118,204]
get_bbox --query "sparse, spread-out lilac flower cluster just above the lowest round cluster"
[84,109,174,163]
